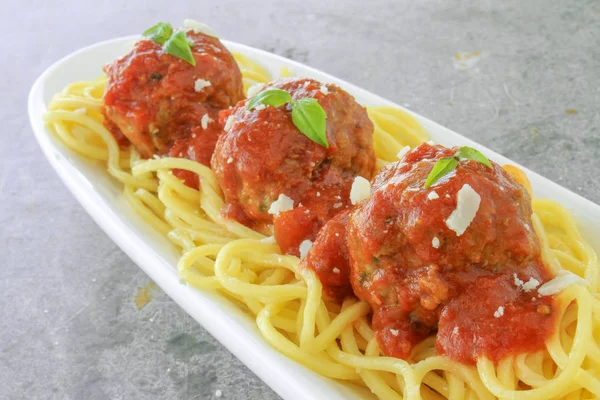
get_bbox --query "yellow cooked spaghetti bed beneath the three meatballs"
[45,50,600,400]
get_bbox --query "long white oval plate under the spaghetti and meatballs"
[29,36,600,399]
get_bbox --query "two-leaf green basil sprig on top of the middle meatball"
[248,89,329,148]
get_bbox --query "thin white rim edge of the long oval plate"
[27,35,600,399]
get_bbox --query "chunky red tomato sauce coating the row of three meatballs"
[104,36,556,364]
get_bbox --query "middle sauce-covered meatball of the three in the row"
[212,79,375,250]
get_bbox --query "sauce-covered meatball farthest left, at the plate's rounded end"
[104,30,244,159]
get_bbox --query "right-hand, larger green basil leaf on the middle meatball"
[292,97,329,148]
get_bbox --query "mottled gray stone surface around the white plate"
[0,0,600,399]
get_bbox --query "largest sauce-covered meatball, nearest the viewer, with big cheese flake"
[347,143,555,364]
